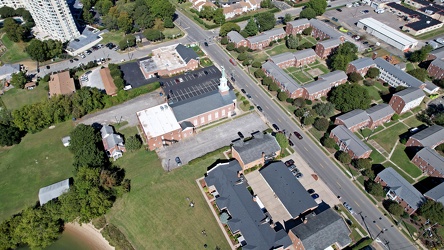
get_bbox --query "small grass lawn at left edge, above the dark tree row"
[1,82,48,110]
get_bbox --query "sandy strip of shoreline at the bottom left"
[65,223,114,250]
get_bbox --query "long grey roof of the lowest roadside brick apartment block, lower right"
[378,168,424,210]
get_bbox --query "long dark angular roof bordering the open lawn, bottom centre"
[205,161,292,250]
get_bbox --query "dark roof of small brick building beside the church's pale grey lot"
[233,134,281,164]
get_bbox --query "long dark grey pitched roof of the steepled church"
[170,90,236,122]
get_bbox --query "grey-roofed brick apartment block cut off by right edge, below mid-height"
[412,147,444,178]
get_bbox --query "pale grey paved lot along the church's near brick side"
[157,113,268,171]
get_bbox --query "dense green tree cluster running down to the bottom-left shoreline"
[0,124,130,249]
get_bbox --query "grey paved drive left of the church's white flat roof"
[77,91,165,127]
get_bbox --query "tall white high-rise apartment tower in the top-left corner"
[0,0,80,42]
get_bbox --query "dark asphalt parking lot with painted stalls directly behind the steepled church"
[161,66,231,103]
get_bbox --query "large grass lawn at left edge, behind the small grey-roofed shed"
[0,121,74,221]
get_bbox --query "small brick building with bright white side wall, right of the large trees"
[389,87,425,114]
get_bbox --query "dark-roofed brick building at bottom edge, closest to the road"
[288,208,352,250]
